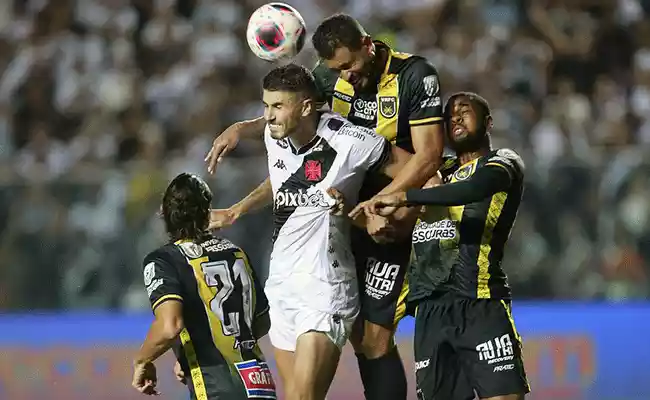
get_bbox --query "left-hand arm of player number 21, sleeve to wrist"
[133,253,185,365]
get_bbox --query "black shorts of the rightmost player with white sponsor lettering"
[414,294,530,400]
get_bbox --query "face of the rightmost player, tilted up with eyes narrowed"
[446,97,485,151]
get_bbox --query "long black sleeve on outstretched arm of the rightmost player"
[406,164,511,206]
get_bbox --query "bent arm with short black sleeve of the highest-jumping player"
[372,60,444,194]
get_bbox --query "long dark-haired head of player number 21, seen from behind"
[162,173,212,240]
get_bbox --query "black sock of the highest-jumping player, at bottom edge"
[357,346,407,400]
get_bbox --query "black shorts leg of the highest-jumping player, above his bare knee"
[352,229,411,329]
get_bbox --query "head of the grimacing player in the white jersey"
[262,64,318,139]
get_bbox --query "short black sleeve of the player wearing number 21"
[142,250,183,310]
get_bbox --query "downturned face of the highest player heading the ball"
[324,37,375,90]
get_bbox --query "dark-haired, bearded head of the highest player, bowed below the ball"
[311,14,381,89]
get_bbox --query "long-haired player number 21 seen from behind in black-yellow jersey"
[133,174,276,400]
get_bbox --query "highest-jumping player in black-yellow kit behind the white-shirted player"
[206,14,444,400]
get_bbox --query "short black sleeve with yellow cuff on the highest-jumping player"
[402,57,443,126]
